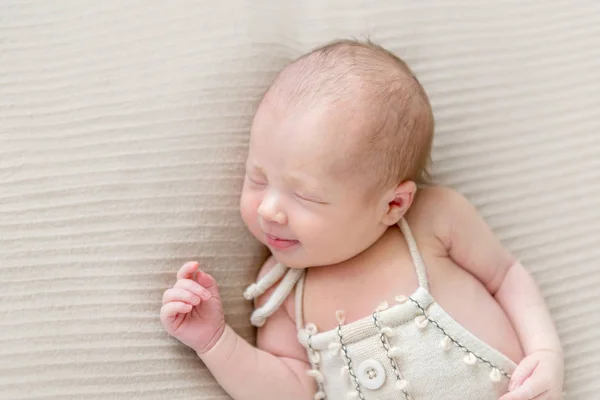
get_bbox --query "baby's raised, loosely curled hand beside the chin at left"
[160,262,225,354]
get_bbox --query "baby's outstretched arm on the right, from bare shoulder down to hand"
[424,188,563,400]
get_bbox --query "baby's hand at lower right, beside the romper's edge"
[500,350,564,400]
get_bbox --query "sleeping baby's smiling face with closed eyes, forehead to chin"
[240,97,385,268]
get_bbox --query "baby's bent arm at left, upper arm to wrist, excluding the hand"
[192,259,316,400]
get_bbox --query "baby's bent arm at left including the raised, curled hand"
[160,262,316,400]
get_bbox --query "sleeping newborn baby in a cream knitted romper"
[161,41,563,400]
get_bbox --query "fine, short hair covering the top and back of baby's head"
[273,40,434,189]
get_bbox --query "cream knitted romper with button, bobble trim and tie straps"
[244,220,516,400]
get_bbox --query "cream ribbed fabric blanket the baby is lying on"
[0,0,600,400]
